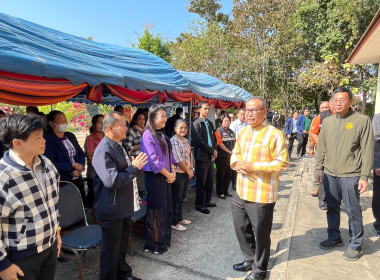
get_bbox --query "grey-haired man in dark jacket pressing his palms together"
[92,112,147,280]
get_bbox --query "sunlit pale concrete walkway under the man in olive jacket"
[270,158,380,280]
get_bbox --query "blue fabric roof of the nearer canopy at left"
[0,13,190,91]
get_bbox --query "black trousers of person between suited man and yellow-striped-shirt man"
[215,157,232,195]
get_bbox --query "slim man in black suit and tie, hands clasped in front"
[193,101,218,214]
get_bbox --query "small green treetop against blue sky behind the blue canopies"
[137,28,171,63]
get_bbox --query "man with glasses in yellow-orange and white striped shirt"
[231,97,289,280]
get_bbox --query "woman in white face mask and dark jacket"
[44,110,85,202]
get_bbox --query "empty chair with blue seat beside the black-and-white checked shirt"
[58,181,102,280]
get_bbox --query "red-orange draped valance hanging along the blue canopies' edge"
[0,71,244,109]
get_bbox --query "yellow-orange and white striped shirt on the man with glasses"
[231,121,289,203]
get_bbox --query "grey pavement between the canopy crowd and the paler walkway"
[56,160,296,280]
